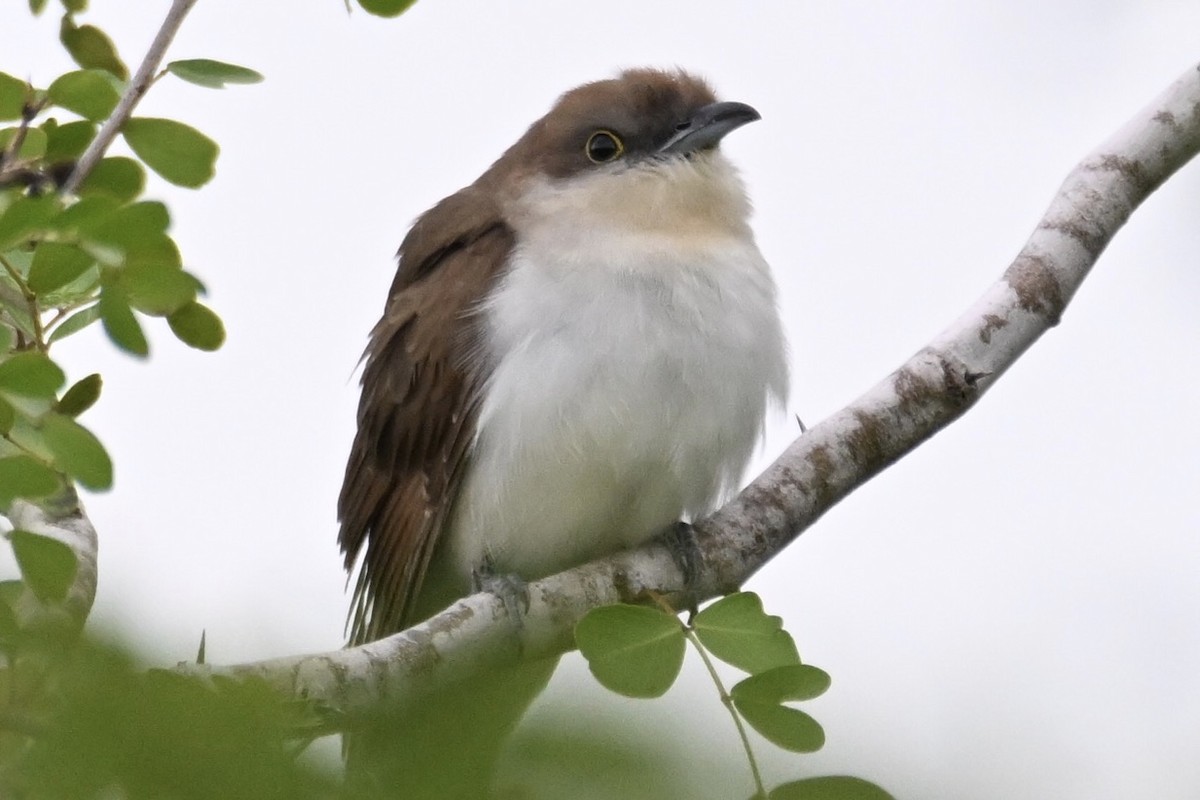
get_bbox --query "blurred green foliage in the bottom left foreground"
[0,642,337,800]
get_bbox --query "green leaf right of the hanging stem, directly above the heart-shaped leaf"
[692,591,800,674]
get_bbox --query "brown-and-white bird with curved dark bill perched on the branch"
[338,68,788,796]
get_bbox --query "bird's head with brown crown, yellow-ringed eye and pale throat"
[484,70,760,242]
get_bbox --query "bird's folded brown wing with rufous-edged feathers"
[338,188,512,644]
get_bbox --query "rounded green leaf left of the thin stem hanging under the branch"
[575,604,684,697]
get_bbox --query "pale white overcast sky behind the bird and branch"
[0,0,1200,800]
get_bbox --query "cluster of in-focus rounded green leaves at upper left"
[0,0,262,513]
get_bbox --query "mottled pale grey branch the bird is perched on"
[192,67,1200,717]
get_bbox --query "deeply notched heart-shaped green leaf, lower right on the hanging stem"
[730,664,829,753]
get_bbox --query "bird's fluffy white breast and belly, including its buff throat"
[444,156,787,579]
